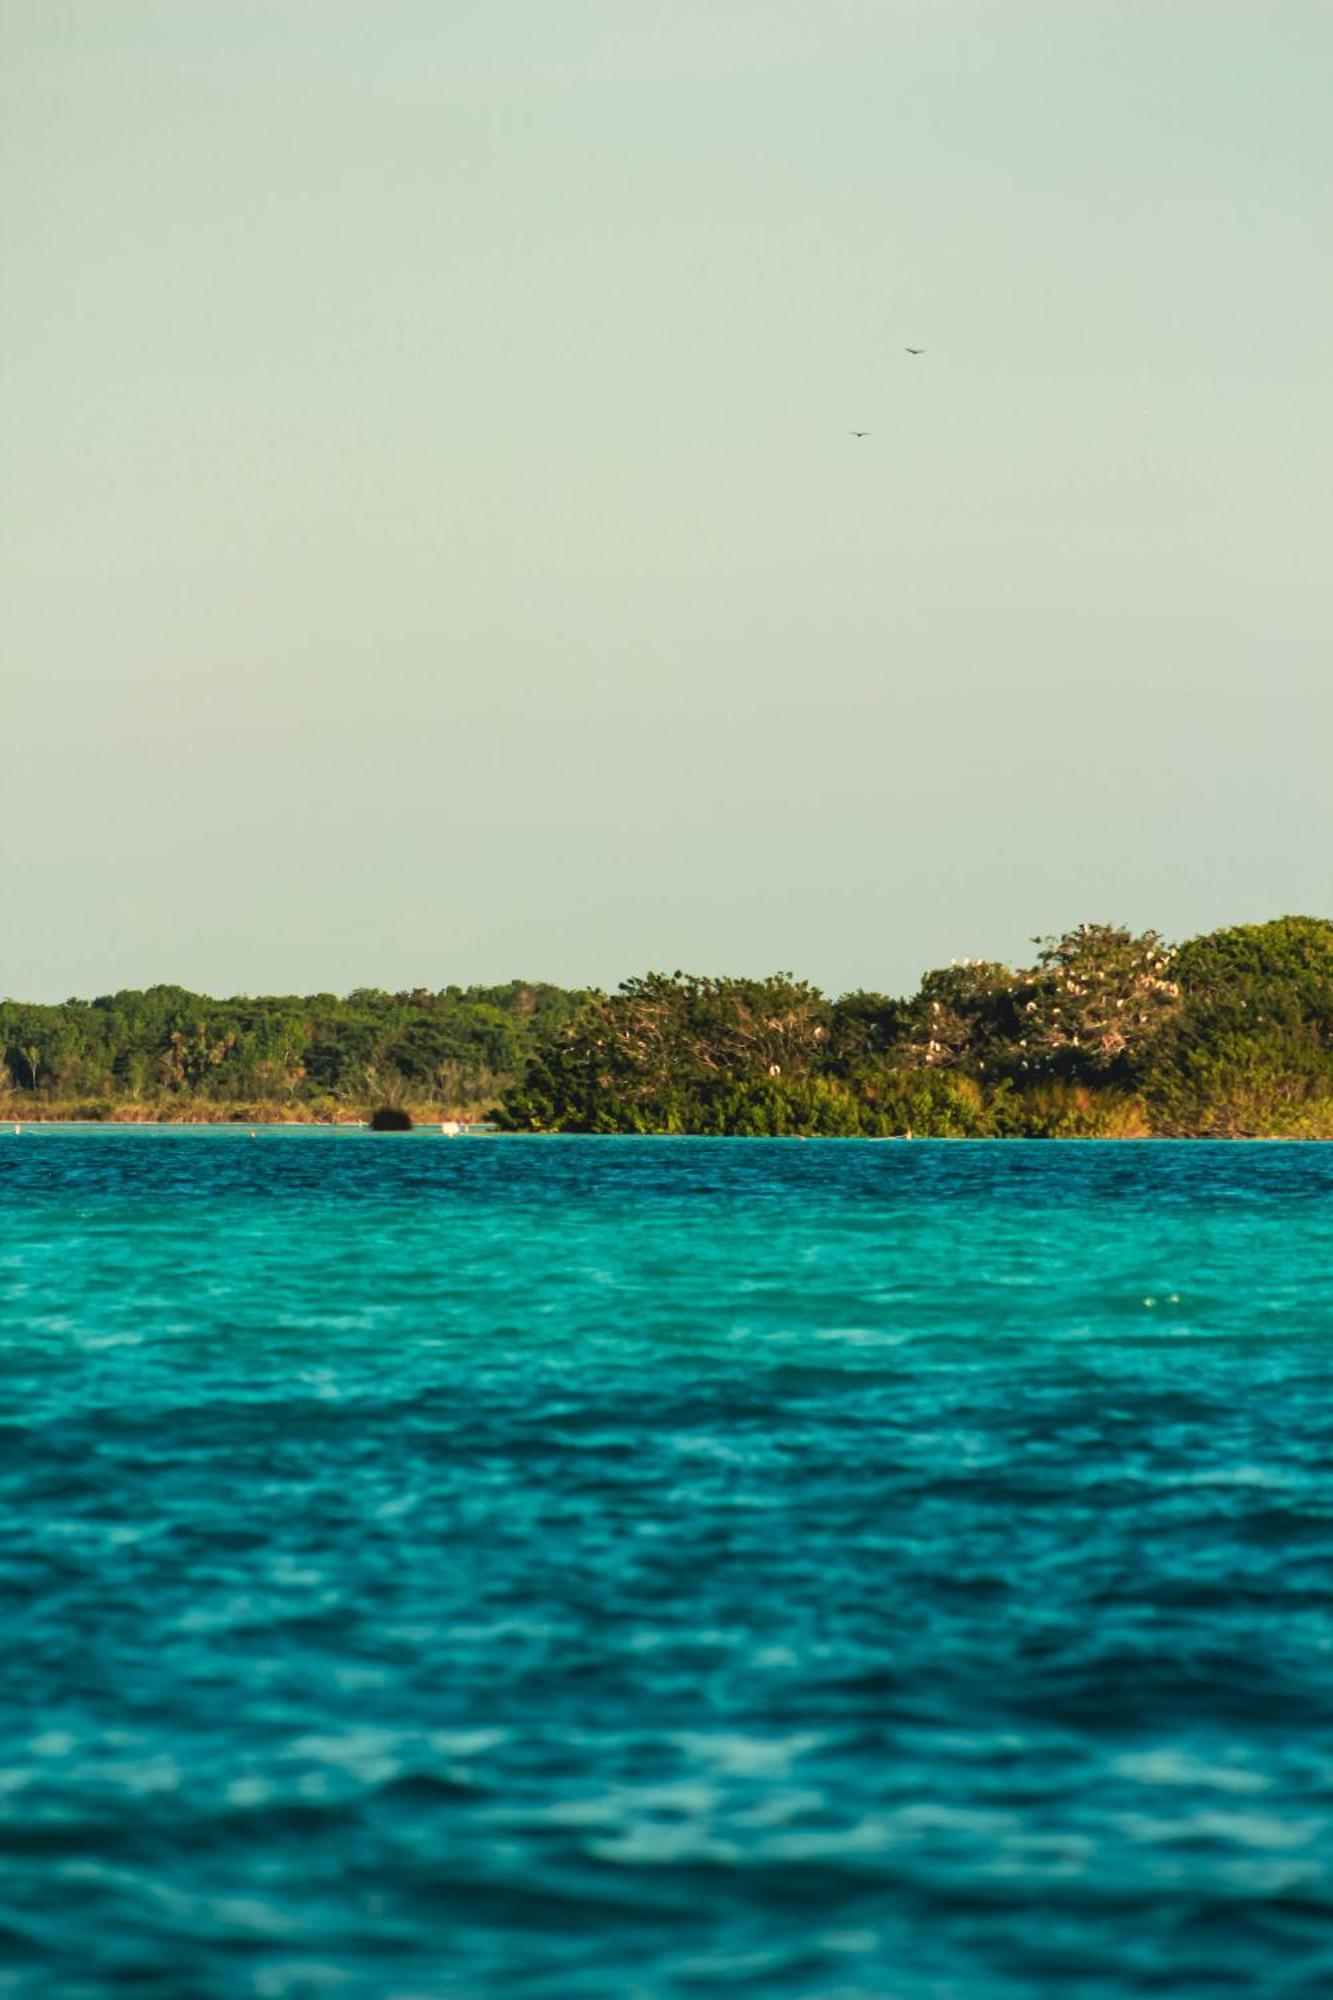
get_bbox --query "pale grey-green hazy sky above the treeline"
[0,0,1333,1000]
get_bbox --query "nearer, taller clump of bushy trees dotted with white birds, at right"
[500,918,1333,1138]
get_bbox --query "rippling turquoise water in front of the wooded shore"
[0,1130,1333,2000]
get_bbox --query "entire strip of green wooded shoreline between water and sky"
[10,916,1333,1138]
